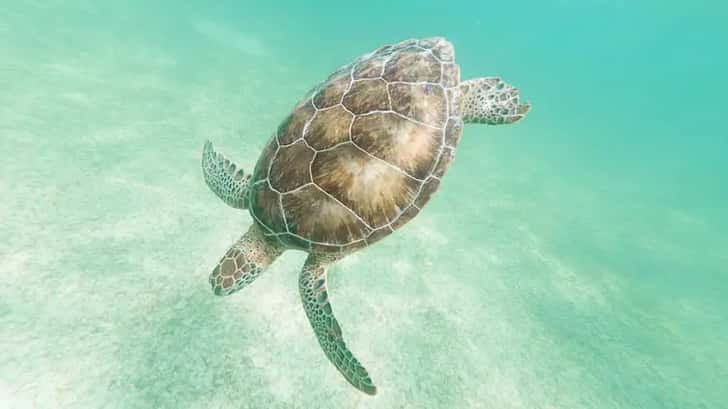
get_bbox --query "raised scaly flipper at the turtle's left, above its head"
[202,141,250,209]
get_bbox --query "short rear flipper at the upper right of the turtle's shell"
[460,77,531,125]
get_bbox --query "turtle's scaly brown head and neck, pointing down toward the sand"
[210,223,283,296]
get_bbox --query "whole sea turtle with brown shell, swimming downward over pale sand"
[202,37,530,395]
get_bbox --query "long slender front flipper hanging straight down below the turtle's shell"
[298,254,377,395]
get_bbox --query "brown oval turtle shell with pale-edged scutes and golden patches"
[249,38,463,252]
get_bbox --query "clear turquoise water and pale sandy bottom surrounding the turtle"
[0,0,728,409]
